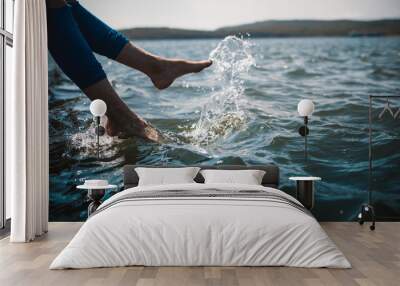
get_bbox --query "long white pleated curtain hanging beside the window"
[6,0,49,242]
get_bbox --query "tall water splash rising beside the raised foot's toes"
[187,36,255,147]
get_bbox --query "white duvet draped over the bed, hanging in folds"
[50,184,351,269]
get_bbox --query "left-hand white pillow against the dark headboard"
[135,167,200,186]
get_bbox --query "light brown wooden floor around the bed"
[0,222,400,286]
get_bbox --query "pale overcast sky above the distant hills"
[80,0,400,29]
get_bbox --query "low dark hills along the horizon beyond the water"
[122,19,400,39]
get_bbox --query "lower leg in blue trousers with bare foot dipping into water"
[47,0,161,141]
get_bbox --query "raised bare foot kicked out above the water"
[148,59,212,89]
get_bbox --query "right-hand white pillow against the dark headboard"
[200,170,265,185]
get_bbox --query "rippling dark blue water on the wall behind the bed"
[49,1,400,221]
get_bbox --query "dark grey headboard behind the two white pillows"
[124,164,279,189]
